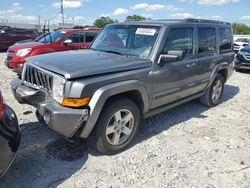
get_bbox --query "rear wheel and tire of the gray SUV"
[200,74,225,107]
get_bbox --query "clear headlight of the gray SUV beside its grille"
[52,76,65,104]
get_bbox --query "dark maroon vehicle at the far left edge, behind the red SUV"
[0,26,39,50]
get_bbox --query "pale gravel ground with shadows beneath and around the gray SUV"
[0,53,250,188]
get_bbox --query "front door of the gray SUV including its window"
[152,25,196,108]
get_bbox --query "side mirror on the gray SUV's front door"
[158,50,184,65]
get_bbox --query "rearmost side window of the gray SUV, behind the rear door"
[219,28,232,51]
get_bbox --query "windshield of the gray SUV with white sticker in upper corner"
[91,25,160,58]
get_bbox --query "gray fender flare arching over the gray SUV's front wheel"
[80,80,149,138]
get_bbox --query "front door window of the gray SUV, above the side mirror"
[163,28,193,55]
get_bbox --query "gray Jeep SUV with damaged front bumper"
[11,19,234,154]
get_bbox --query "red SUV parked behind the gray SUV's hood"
[5,29,99,73]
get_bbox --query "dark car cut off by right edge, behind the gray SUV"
[235,46,250,71]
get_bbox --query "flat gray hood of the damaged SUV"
[26,50,152,79]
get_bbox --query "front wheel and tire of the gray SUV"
[95,99,140,155]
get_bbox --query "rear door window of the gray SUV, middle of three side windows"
[198,28,216,53]
